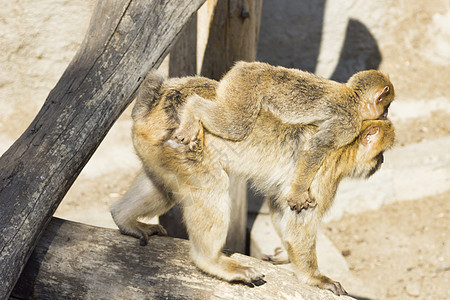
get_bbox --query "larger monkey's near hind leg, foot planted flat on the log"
[183,174,265,286]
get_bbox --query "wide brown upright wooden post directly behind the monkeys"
[198,0,263,253]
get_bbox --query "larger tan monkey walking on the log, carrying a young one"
[111,73,395,295]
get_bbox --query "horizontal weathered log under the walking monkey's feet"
[11,218,349,300]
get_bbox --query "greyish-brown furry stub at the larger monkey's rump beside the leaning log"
[131,70,164,121]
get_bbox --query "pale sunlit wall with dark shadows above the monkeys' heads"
[258,0,450,98]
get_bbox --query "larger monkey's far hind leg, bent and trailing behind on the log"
[111,171,174,246]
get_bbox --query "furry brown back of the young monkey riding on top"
[224,62,358,125]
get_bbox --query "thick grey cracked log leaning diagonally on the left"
[0,0,203,299]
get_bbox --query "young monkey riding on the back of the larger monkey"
[173,61,394,211]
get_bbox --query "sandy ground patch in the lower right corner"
[324,192,450,299]
